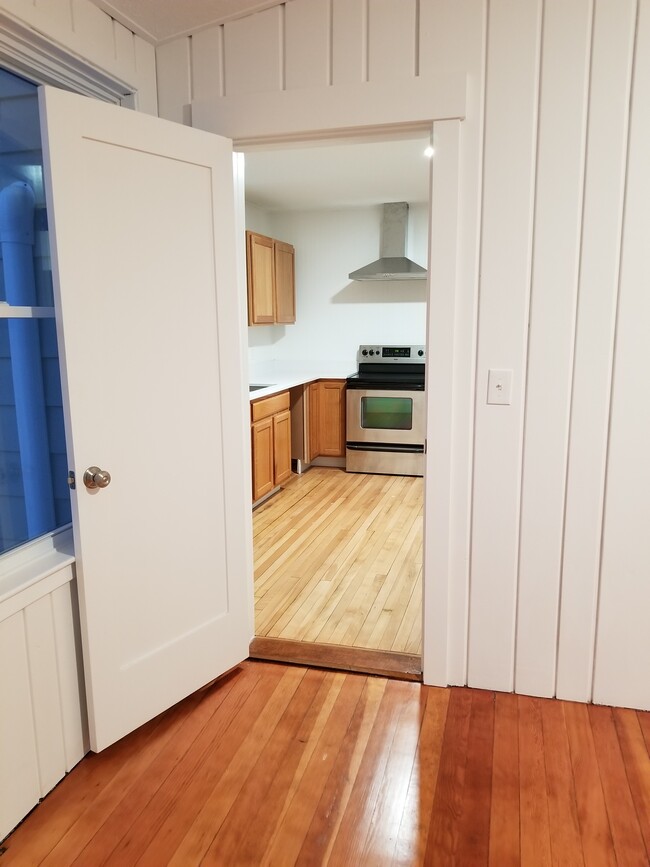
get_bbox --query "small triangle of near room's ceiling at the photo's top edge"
[92,0,281,44]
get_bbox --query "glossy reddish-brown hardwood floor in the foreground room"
[0,662,650,867]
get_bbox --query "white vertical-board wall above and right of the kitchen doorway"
[158,0,650,708]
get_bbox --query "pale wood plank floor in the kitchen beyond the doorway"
[253,467,423,654]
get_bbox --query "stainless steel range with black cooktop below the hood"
[346,345,426,476]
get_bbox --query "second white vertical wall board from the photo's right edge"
[556,0,636,701]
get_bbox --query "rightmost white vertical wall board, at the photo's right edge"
[593,3,650,710]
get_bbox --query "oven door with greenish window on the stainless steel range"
[346,388,425,450]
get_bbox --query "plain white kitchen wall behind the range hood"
[246,205,429,373]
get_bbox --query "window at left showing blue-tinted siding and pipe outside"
[0,69,70,553]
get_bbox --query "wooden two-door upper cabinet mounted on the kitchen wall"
[246,232,296,325]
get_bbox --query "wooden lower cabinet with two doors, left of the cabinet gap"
[251,391,291,502]
